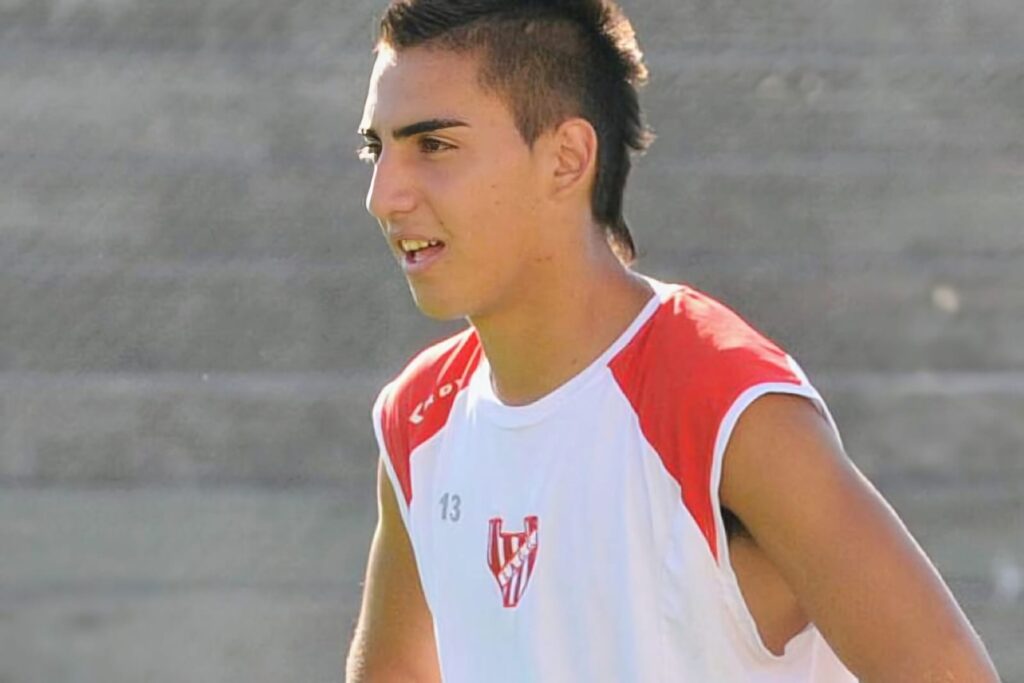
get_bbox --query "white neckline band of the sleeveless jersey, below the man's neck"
[467,275,675,428]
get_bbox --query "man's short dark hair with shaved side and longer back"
[377,0,653,263]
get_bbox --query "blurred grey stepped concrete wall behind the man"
[0,0,1024,683]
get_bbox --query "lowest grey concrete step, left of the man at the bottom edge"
[0,589,358,683]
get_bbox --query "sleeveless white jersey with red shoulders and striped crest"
[374,281,856,683]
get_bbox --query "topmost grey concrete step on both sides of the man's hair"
[0,0,1024,51]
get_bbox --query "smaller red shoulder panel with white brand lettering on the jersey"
[380,329,480,505]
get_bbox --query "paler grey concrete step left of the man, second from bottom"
[0,485,377,589]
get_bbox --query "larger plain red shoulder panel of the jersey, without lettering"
[609,287,801,559]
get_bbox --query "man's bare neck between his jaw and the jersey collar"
[470,249,652,405]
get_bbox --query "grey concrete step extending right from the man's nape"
[626,163,1024,259]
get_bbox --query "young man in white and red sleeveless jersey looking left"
[348,0,996,683]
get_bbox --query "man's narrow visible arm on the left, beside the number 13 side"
[345,458,441,683]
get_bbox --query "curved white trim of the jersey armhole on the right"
[710,358,842,660]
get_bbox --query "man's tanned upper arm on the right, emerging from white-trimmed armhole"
[721,394,997,683]
